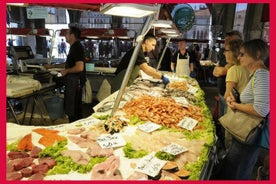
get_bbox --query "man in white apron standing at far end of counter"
[171,40,194,76]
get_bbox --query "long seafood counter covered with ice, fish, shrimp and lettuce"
[7,76,215,180]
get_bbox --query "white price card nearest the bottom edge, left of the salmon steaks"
[135,152,167,177]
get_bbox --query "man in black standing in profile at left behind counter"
[44,27,86,122]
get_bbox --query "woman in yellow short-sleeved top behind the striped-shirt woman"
[224,39,249,149]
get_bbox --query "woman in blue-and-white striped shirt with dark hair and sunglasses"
[218,39,270,180]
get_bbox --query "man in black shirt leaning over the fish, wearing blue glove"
[112,34,169,91]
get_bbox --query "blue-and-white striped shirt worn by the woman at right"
[240,69,270,117]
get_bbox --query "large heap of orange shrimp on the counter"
[122,96,203,128]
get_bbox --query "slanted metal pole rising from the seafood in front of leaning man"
[111,15,154,116]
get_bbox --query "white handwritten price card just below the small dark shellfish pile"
[97,134,126,148]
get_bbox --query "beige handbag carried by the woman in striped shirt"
[219,109,265,144]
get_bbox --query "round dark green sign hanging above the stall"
[171,4,195,32]
